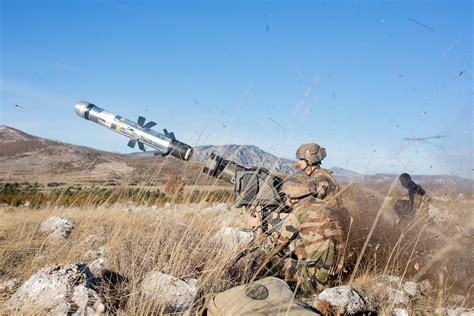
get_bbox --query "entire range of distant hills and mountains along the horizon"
[0,125,474,191]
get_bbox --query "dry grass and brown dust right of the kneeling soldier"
[344,186,474,313]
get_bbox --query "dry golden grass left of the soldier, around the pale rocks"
[0,205,260,314]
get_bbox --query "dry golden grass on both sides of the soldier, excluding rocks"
[0,186,474,314]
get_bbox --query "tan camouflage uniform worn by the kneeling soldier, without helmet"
[257,169,344,284]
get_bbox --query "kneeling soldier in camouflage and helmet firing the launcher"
[249,144,344,292]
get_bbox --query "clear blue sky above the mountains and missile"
[0,0,473,178]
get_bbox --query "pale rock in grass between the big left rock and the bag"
[141,271,198,312]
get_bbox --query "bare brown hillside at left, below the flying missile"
[0,125,206,185]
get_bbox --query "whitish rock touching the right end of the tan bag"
[318,285,367,314]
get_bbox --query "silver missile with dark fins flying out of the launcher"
[75,101,193,161]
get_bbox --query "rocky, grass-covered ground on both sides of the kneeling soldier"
[0,187,473,315]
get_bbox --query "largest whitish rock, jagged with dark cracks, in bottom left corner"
[8,262,105,315]
